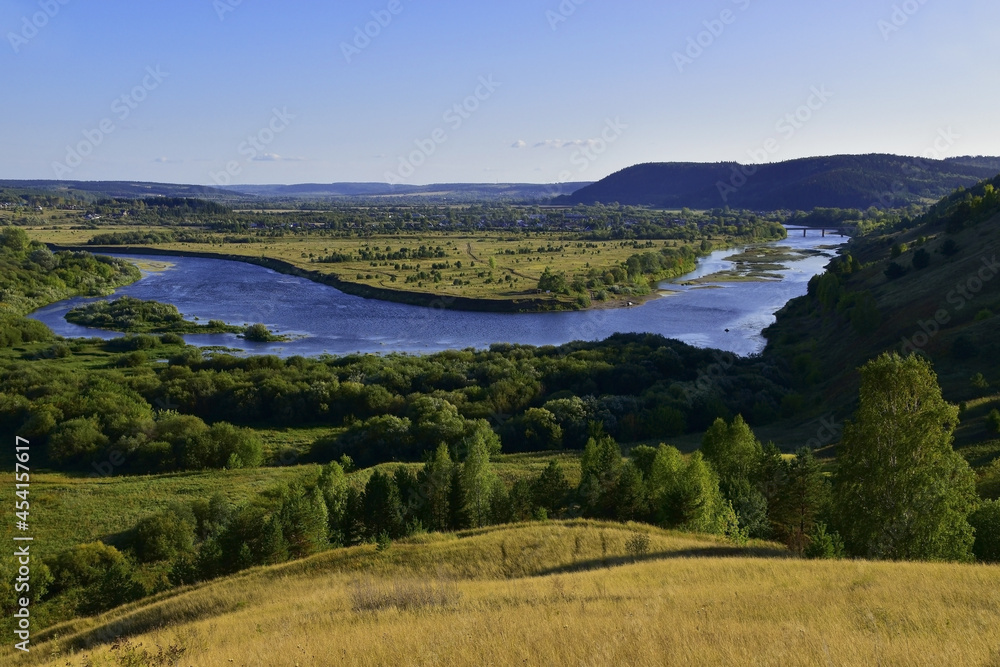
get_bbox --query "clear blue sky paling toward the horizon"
[0,0,1000,185]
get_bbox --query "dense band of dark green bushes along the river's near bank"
[0,334,787,472]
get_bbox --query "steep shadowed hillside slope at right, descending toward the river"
[765,190,1000,444]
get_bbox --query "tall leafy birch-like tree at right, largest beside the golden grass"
[834,353,976,560]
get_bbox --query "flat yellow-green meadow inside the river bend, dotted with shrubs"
[26,219,735,310]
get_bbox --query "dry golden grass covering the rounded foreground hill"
[15,522,1000,666]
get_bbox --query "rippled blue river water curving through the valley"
[32,232,846,356]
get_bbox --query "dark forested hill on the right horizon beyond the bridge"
[556,154,1000,211]
